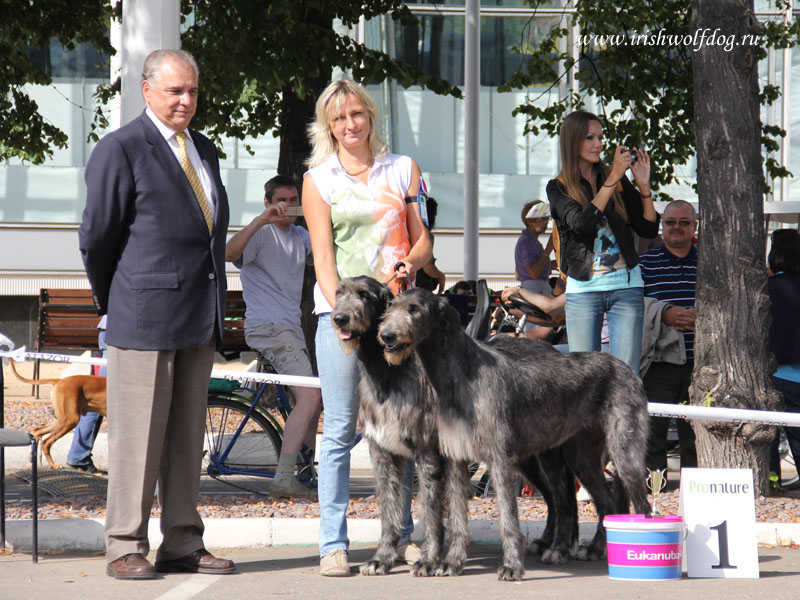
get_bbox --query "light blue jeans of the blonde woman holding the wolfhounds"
[316,313,414,556]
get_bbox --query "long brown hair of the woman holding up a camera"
[558,110,628,221]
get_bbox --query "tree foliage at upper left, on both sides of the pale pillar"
[0,0,461,164]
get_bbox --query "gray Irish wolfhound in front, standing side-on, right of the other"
[378,289,650,580]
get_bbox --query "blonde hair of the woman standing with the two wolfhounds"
[306,79,389,167]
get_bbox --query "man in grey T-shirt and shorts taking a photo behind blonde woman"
[225,175,321,495]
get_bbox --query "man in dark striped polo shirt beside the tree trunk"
[639,200,697,469]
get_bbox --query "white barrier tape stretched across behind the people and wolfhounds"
[6,346,800,427]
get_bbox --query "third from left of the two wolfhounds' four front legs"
[436,460,472,576]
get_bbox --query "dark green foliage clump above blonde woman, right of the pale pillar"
[176,0,461,155]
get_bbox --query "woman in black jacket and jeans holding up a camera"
[547,110,658,374]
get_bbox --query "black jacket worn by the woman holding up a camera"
[547,173,659,281]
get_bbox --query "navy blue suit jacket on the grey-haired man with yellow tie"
[78,113,228,350]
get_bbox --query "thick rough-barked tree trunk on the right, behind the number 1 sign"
[691,0,782,495]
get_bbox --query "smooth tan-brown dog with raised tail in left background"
[9,359,106,469]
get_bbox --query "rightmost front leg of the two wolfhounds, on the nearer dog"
[489,451,525,581]
